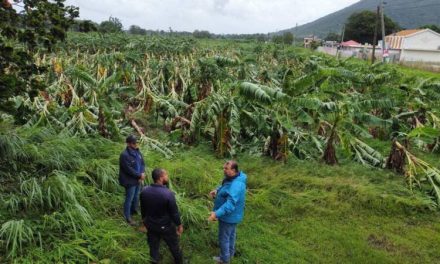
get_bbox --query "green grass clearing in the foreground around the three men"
[0,142,440,263]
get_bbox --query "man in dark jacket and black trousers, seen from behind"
[141,169,183,264]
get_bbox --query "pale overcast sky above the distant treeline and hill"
[66,0,359,33]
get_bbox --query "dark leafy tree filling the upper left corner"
[0,0,79,116]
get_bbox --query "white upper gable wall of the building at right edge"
[402,31,440,50]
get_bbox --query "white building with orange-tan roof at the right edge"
[385,29,440,63]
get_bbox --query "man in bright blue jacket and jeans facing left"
[208,161,247,263]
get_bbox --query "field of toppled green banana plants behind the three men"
[25,35,440,196]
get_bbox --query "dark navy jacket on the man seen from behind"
[141,184,181,229]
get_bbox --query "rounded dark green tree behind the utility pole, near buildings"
[344,11,400,43]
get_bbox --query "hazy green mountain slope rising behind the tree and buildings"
[278,0,440,37]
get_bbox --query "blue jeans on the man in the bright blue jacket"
[218,221,237,263]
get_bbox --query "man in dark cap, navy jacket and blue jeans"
[119,135,145,226]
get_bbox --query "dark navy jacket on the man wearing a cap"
[119,147,145,187]
